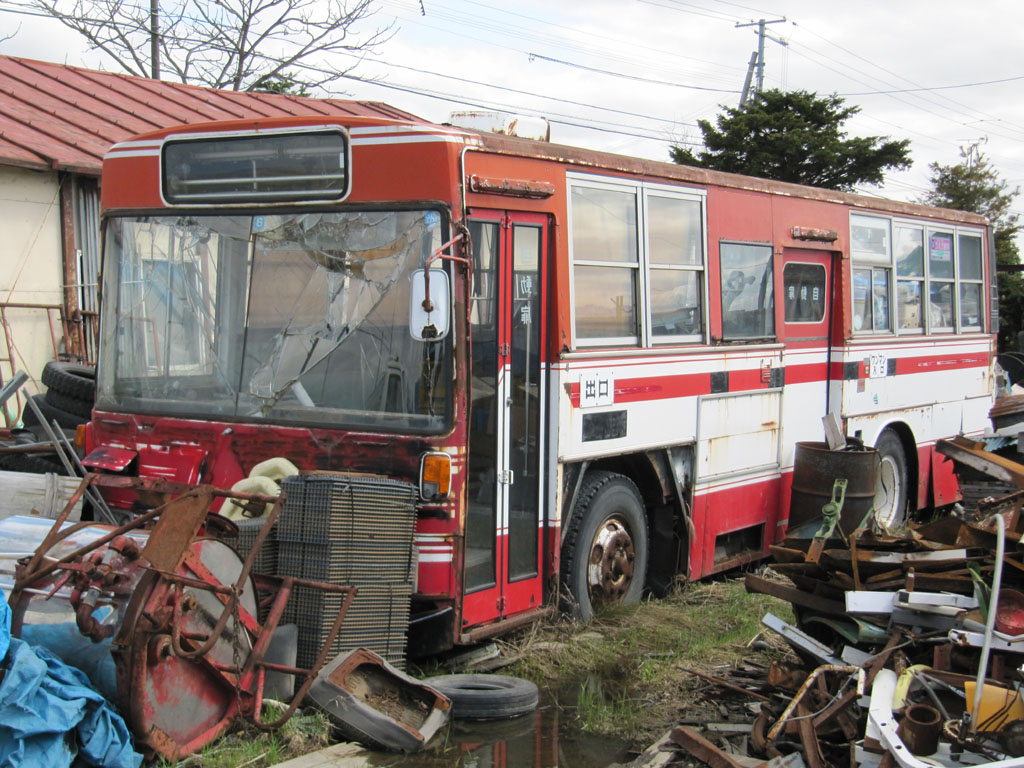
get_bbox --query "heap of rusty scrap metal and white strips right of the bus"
[644,438,1024,768]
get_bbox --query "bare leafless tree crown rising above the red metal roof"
[32,0,393,90]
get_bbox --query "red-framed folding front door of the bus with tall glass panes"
[463,212,547,627]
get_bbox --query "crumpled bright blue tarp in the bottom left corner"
[0,590,142,768]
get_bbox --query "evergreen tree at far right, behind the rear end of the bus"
[921,143,1024,351]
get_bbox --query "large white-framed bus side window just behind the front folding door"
[567,174,706,346]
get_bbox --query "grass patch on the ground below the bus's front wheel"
[505,579,793,742]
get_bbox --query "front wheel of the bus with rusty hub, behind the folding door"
[562,471,647,622]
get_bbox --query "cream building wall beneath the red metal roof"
[0,166,63,427]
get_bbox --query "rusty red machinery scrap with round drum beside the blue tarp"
[0,474,356,761]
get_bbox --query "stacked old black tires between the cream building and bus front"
[0,360,96,474]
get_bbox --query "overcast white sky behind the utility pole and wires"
[0,0,1024,219]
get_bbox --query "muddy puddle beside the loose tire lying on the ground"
[360,706,627,768]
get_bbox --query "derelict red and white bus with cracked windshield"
[87,117,996,651]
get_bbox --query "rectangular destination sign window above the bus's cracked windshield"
[163,129,349,205]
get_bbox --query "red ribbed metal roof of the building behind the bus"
[0,56,421,174]
